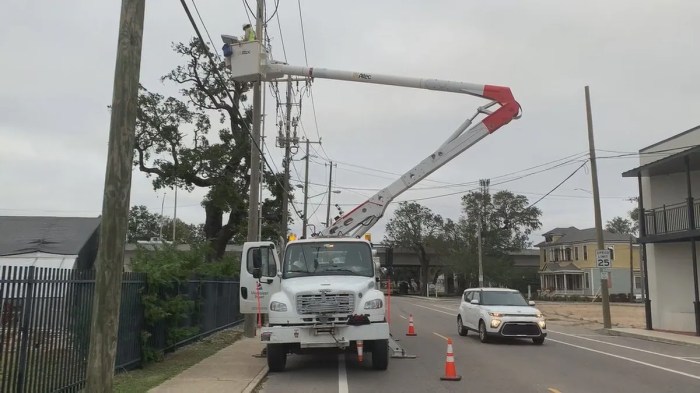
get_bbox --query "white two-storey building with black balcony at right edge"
[622,126,700,336]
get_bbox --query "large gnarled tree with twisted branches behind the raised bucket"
[134,38,284,259]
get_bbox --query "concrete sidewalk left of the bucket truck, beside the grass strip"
[148,336,267,393]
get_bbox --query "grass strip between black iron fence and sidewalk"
[114,329,242,393]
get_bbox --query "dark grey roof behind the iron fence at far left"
[0,216,100,256]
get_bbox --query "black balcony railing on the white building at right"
[644,201,700,235]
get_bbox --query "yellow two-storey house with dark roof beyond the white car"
[537,227,642,296]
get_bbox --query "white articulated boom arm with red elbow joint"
[263,63,520,237]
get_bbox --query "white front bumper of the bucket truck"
[260,322,389,348]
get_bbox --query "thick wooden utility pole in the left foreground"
[85,0,145,393]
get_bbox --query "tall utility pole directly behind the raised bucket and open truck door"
[243,0,265,337]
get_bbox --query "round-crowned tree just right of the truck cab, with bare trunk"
[384,202,443,294]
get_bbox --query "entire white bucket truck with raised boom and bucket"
[222,35,521,371]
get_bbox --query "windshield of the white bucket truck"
[282,241,374,278]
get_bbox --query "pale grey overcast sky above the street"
[0,0,700,242]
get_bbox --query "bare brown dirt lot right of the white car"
[536,301,644,329]
